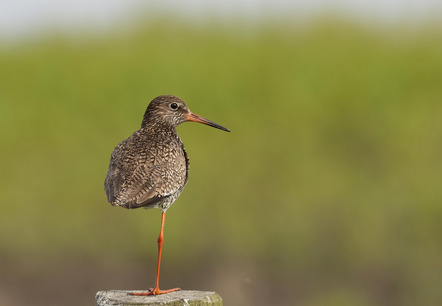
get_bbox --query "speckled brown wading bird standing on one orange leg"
[104,95,230,296]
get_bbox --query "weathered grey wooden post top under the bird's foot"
[95,290,223,306]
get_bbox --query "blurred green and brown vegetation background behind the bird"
[0,2,442,306]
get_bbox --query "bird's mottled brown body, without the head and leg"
[105,126,189,210]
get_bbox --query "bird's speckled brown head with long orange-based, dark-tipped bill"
[141,95,230,132]
